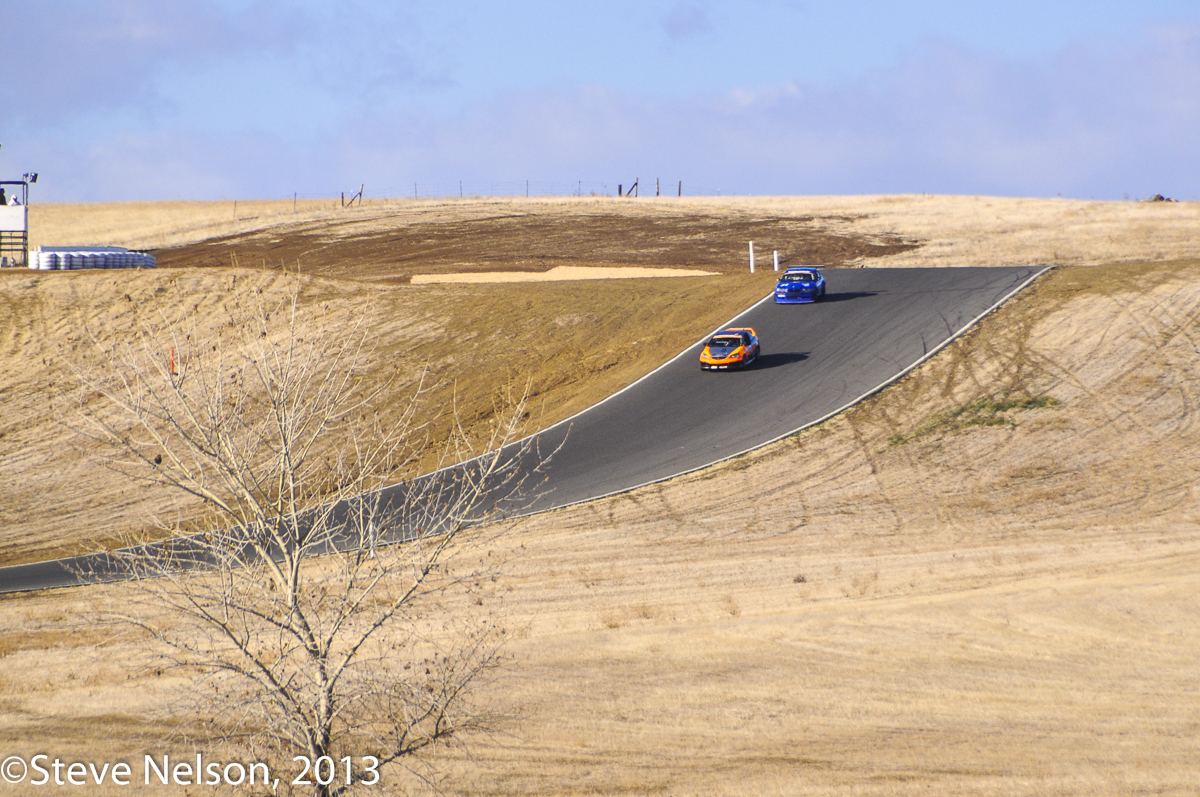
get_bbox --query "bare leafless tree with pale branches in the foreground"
[70,283,549,796]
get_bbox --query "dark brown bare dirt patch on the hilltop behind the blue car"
[155,205,917,282]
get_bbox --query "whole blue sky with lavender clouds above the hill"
[0,0,1200,202]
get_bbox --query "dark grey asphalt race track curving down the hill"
[0,266,1045,593]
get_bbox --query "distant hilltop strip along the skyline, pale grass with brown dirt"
[30,194,1200,273]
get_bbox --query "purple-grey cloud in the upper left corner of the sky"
[0,0,444,134]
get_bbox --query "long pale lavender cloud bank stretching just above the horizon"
[6,23,1200,199]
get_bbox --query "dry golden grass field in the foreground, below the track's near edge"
[0,260,1200,795]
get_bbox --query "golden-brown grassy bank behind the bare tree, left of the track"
[0,269,769,564]
